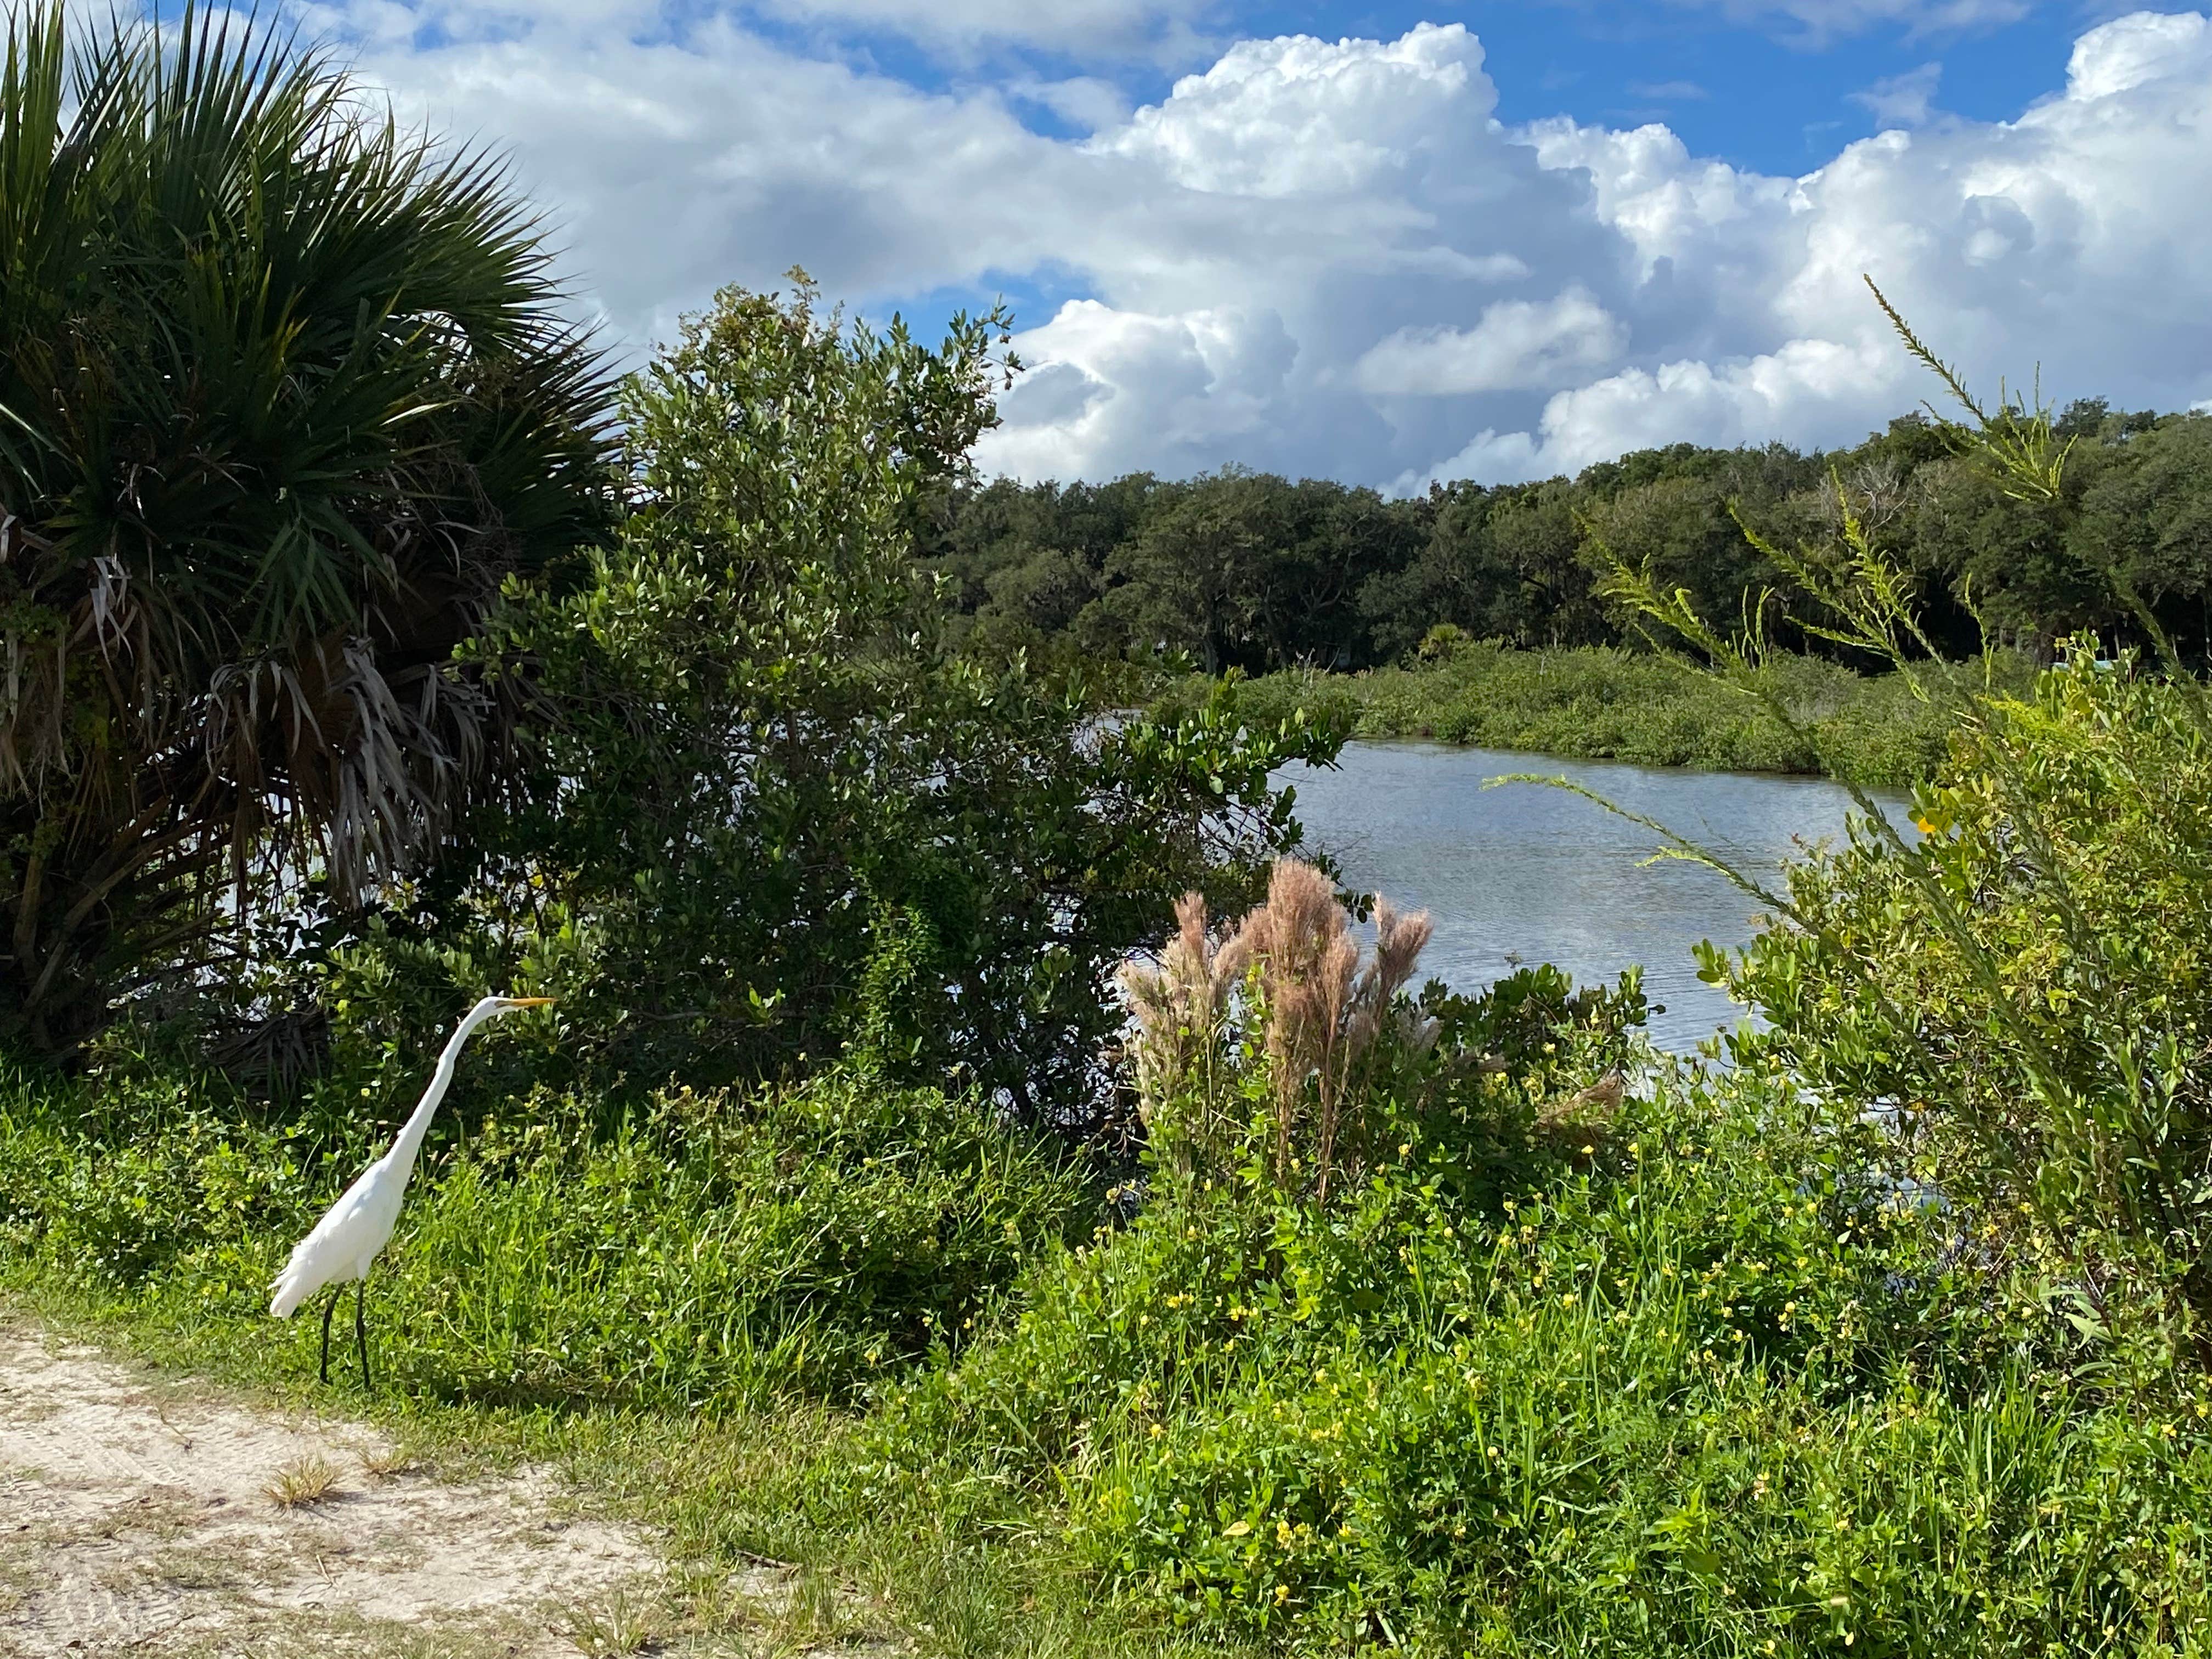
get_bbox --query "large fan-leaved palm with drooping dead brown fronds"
[0,4,611,1051]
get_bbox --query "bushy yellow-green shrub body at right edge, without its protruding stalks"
[1706,654,2212,1352]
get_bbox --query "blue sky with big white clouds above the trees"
[294,0,2212,491]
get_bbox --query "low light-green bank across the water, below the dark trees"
[1170,641,2028,787]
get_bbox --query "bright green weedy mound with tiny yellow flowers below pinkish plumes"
[838,1068,2212,1659]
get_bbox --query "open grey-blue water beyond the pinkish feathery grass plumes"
[1285,743,1905,1048]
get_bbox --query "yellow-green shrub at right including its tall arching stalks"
[1606,305,2212,1376]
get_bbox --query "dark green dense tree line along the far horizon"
[929,398,2212,673]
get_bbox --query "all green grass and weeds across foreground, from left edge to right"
[17,1035,2212,1659]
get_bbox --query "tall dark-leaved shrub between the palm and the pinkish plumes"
[393,274,1334,1130]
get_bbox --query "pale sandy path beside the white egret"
[0,1314,659,1659]
